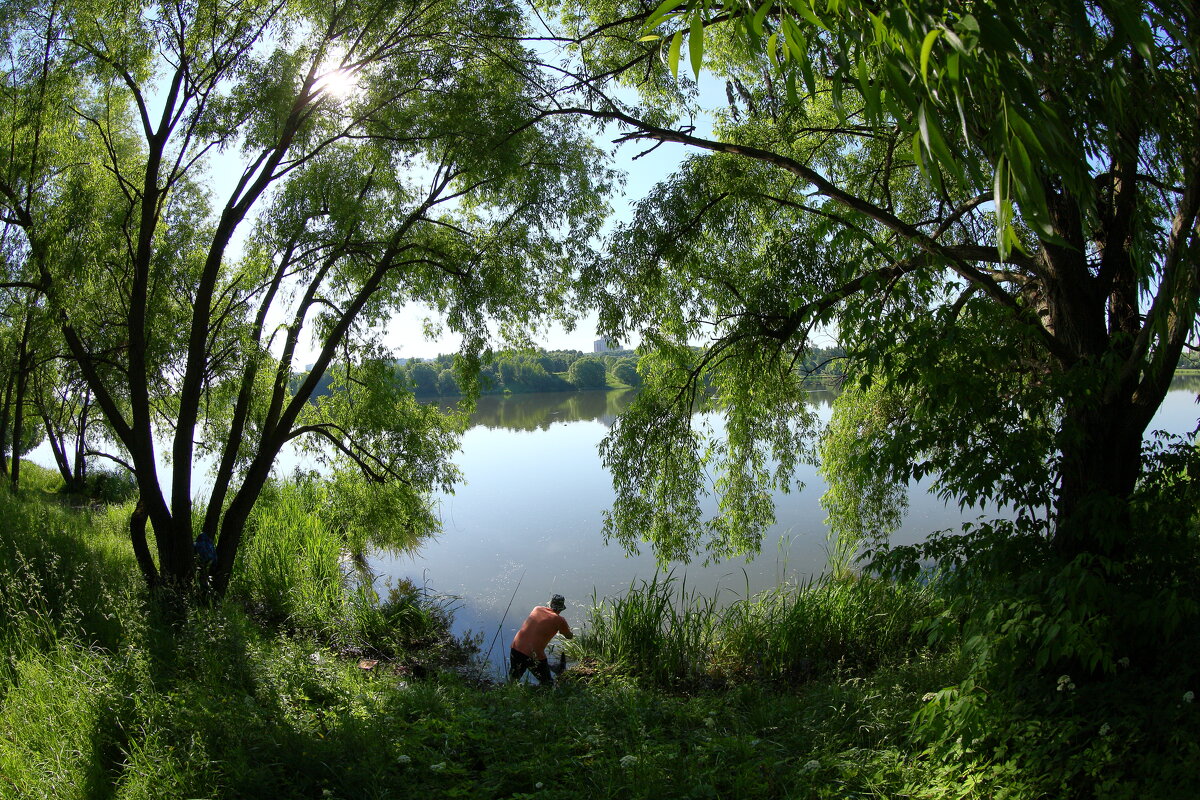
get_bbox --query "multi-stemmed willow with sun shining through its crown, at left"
[0,0,604,591]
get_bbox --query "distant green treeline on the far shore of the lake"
[295,348,845,397]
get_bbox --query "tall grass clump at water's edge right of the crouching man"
[571,575,941,686]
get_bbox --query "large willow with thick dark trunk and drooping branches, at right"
[540,0,1200,561]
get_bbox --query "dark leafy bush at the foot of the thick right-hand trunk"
[875,437,1200,800]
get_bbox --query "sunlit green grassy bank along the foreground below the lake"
[0,465,1198,800]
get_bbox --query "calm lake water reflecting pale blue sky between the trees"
[371,379,1200,663]
